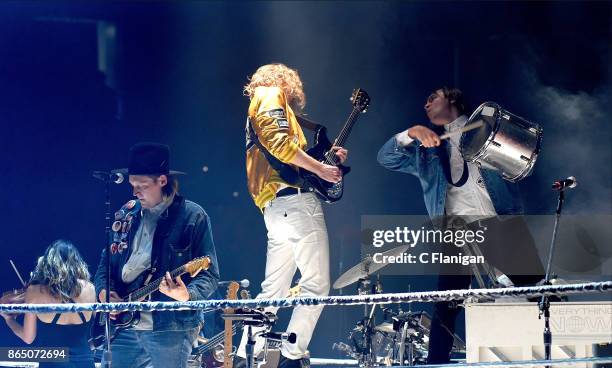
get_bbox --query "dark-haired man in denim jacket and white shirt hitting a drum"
[378,87,544,364]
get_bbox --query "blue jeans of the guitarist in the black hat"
[105,328,198,368]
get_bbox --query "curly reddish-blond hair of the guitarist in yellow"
[244,63,306,111]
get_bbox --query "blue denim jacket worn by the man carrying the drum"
[378,136,523,218]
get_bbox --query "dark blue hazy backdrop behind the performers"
[0,1,612,357]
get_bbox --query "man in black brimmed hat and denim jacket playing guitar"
[95,143,219,367]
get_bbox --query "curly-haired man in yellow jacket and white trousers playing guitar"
[238,64,348,368]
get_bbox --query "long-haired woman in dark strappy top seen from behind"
[2,240,95,368]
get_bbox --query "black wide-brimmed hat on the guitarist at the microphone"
[113,142,185,175]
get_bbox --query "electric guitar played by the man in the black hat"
[89,257,211,349]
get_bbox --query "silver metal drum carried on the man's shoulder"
[460,102,542,182]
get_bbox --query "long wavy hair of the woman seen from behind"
[30,239,89,302]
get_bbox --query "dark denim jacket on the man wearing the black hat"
[94,195,219,331]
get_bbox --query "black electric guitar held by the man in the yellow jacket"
[299,88,370,203]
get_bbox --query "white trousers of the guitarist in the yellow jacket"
[238,193,329,359]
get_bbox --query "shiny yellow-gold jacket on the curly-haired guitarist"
[246,87,306,210]
